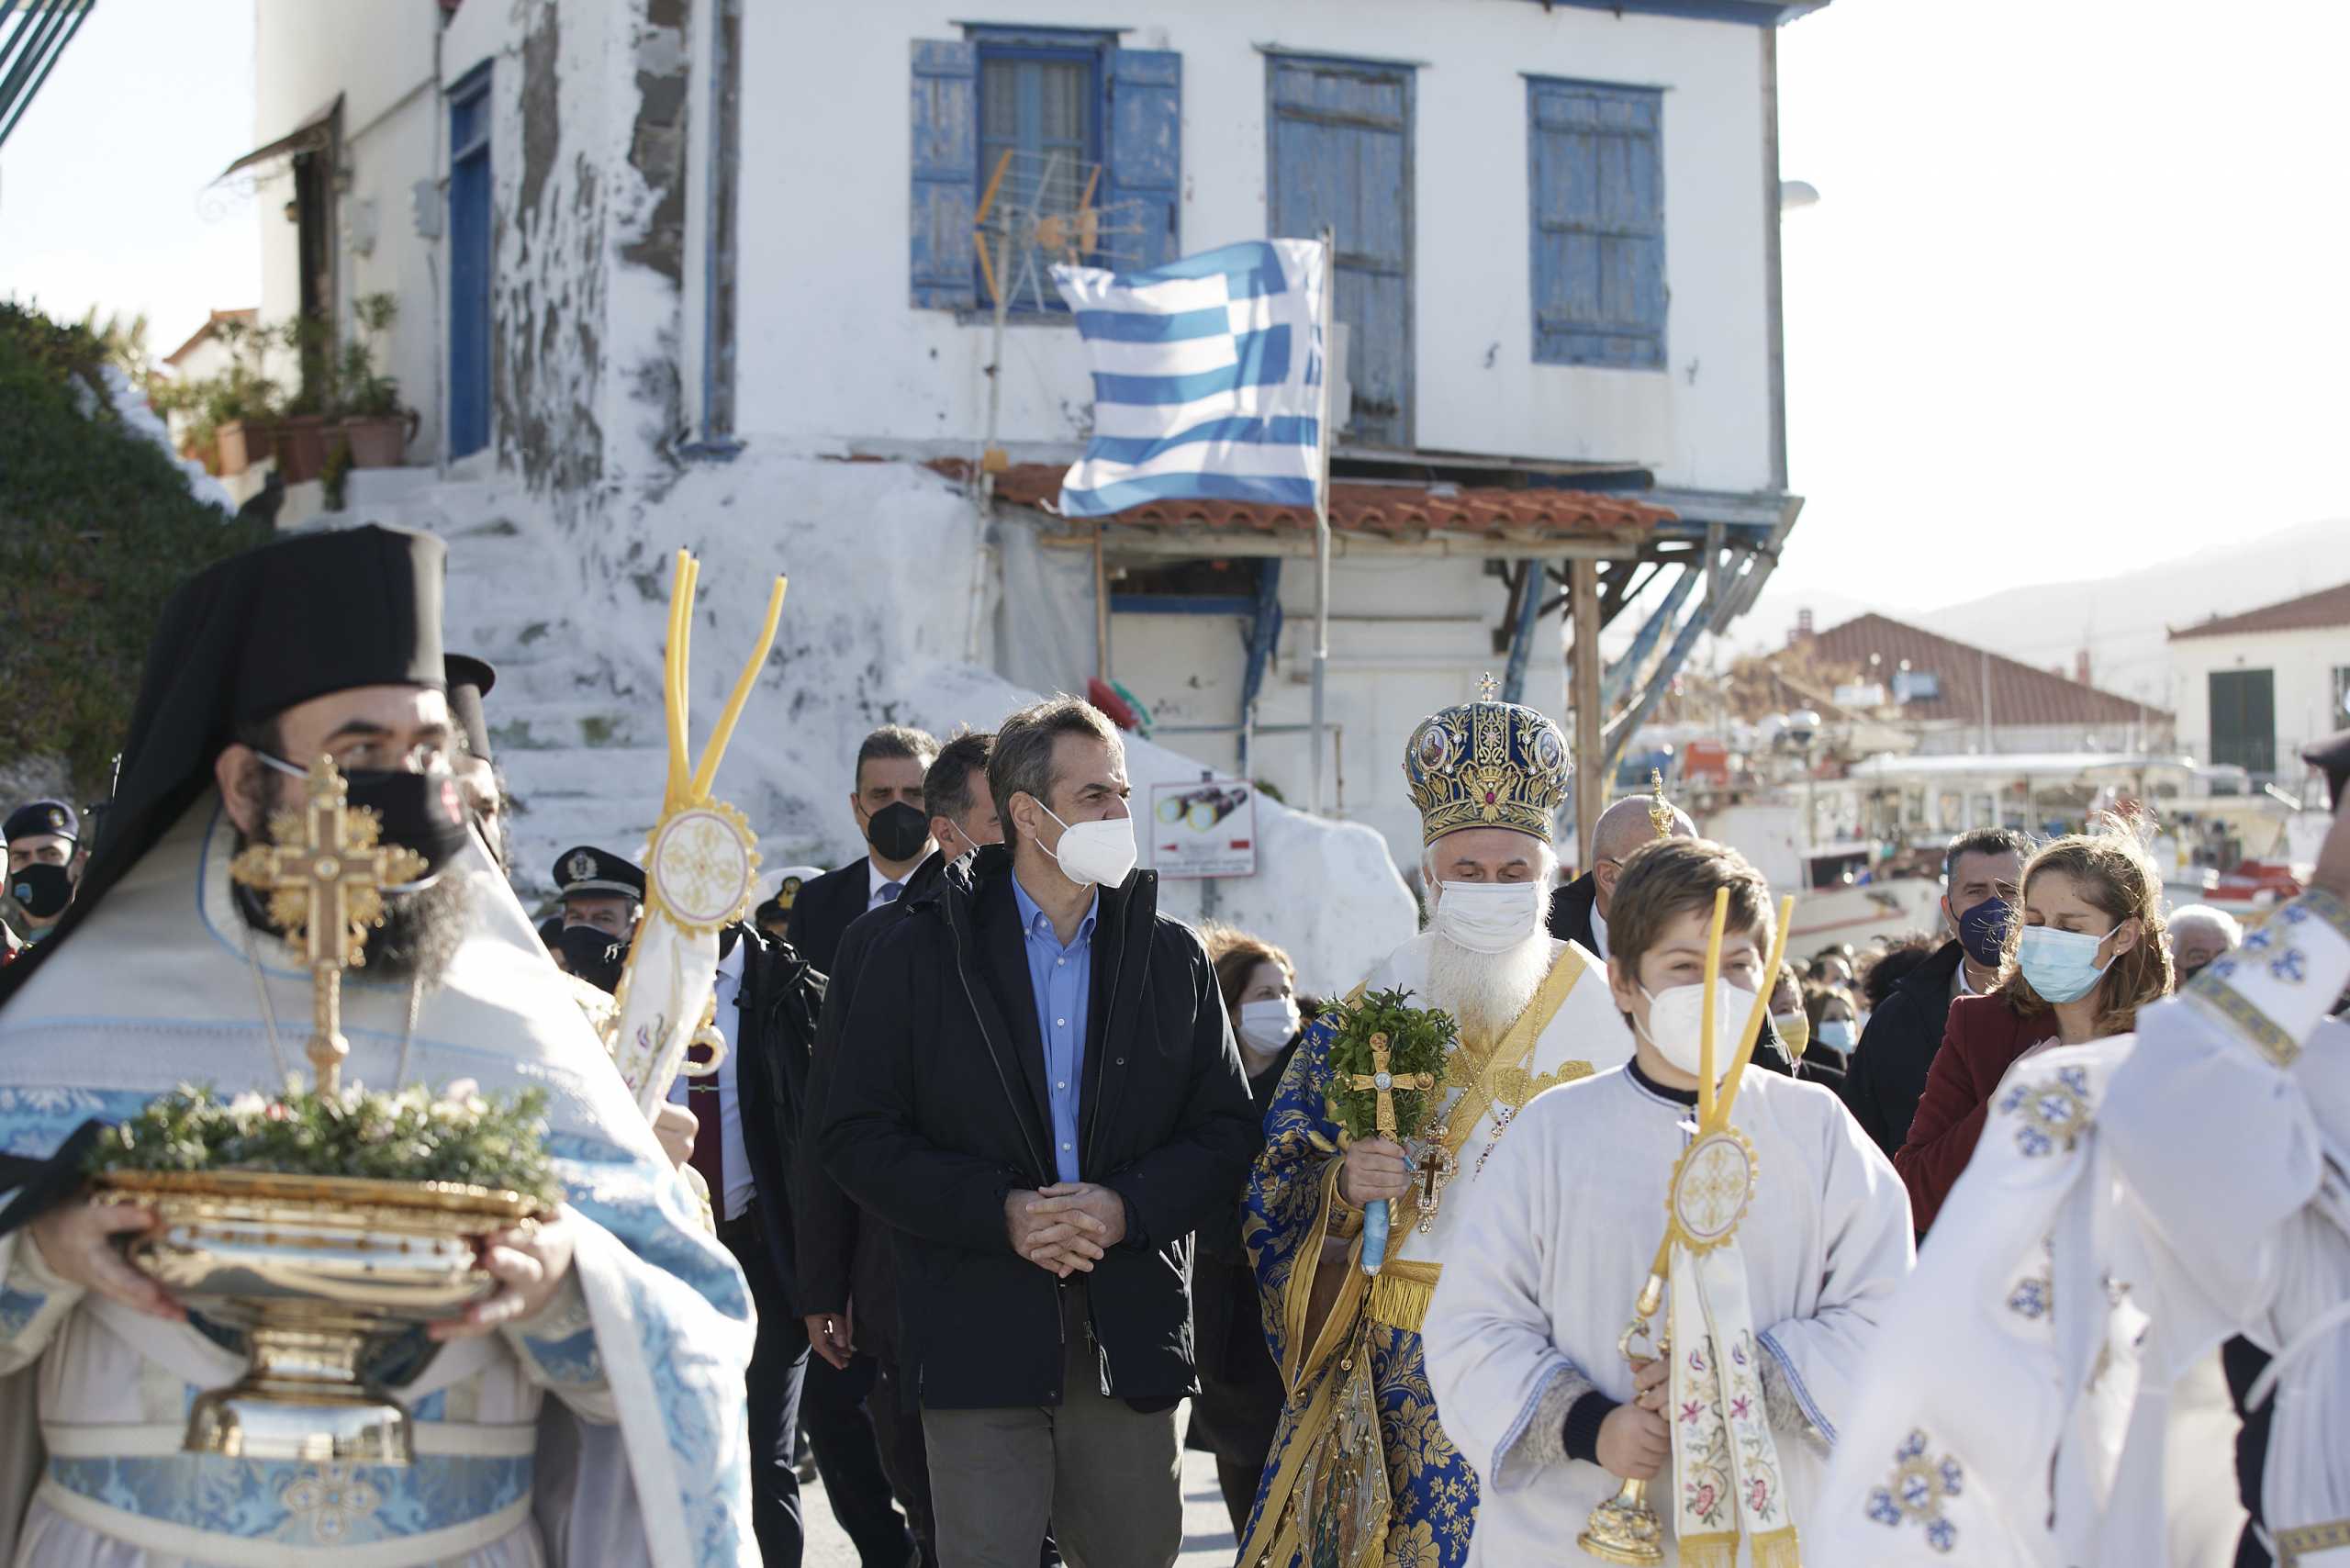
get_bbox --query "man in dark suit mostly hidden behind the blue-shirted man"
[792,731,1003,1563]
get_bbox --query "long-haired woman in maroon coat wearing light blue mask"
[1894,818,2171,1234]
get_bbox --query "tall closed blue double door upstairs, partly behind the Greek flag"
[1267,54,1413,447]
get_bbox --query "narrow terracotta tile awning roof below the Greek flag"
[931,458,1675,543]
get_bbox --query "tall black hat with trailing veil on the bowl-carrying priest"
[0,524,449,1003]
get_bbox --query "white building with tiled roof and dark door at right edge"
[2171,583,2350,788]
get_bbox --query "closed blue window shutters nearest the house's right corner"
[1525,78,1669,369]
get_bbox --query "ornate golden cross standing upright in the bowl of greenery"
[228,757,425,1093]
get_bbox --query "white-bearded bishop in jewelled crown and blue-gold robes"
[1241,696,1633,1568]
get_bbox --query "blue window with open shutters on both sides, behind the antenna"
[910,24,1182,319]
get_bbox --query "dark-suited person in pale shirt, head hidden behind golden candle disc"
[670,924,832,1568]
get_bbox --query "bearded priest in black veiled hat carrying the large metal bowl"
[0,527,756,1568]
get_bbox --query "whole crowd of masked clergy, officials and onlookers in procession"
[0,529,2350,1568]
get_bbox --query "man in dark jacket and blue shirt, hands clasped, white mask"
[825,699,1259,1568]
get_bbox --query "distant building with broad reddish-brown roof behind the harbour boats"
[1774,616,2174,757]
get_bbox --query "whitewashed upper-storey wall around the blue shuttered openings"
[738,0,1776,489]
